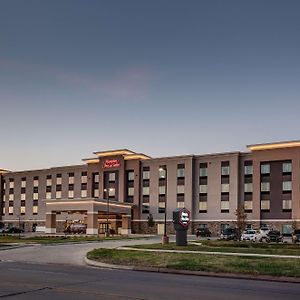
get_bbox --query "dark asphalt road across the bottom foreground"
[0,261,300,300]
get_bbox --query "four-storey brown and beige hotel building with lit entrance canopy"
[0,141,300,235]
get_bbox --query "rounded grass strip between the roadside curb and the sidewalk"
[87,249,300,277]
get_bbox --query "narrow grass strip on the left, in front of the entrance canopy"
[0,234,142,245]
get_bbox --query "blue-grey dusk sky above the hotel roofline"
[0,0,300,170]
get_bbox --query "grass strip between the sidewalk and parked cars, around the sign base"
[127,240,300,256]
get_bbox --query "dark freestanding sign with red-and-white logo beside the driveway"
[173,208,191,246]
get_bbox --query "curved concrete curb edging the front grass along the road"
[84,256,300,283]
